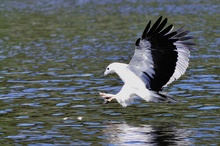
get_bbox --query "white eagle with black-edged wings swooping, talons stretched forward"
[99,16,195,107]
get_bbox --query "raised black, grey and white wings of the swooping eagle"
[128,16,195,91]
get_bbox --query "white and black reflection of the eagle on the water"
[103,124,192,146]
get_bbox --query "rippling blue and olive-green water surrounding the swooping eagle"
[0,0,220,146]
